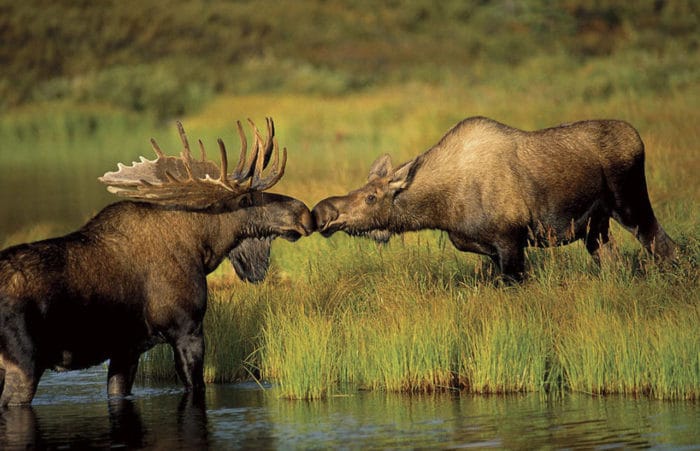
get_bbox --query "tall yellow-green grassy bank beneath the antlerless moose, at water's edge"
[142,228,700,399]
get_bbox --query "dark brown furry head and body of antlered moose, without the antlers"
[0,192,313,406]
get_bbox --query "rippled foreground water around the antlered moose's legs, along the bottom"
[0,366,700,450]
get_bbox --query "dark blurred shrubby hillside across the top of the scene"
[0,0,700,120]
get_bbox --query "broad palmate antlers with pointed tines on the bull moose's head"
[98,118,287,208]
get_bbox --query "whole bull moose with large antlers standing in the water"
[0,119,314,406]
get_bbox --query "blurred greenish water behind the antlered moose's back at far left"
[0,109,156,240]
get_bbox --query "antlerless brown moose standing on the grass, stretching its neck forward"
[312,117,675,281]
